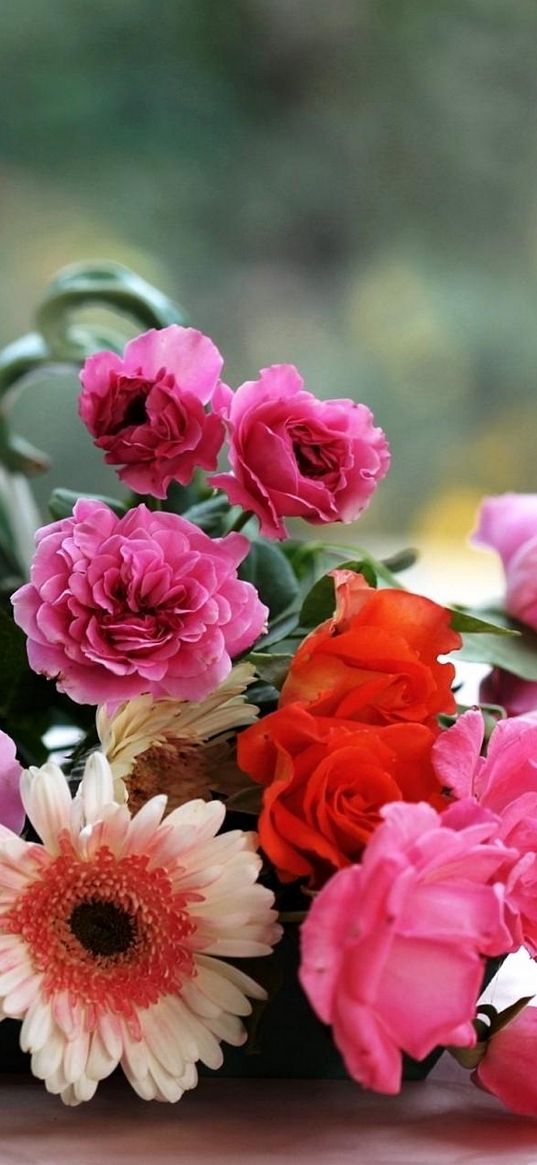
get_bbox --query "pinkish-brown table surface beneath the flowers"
[0,1057,537,1165]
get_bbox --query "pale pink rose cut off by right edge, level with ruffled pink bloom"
[472,494,537,629]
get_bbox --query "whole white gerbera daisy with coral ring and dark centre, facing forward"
[0,753,280,1104]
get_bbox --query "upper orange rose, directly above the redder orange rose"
[280,570,461,727]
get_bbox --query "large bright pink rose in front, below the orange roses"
[299,802,518,1093]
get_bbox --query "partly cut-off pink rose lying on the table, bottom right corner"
[472,1007,537,1116]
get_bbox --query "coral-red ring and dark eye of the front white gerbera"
[0,835,199,1028]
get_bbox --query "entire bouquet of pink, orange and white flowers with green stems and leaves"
[0,264,537,1114]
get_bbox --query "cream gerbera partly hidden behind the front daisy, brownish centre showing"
[97,663,257,810]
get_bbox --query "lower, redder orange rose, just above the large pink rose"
[238,704,445,887]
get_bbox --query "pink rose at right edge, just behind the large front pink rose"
[432,708,537,955]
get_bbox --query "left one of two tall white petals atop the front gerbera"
[21,761,71,854]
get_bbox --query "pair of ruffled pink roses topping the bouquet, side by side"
[79,325,389,538]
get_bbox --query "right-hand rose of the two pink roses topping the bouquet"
[211,365,390,538]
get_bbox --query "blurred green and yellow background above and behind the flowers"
[0,0,537,537]
